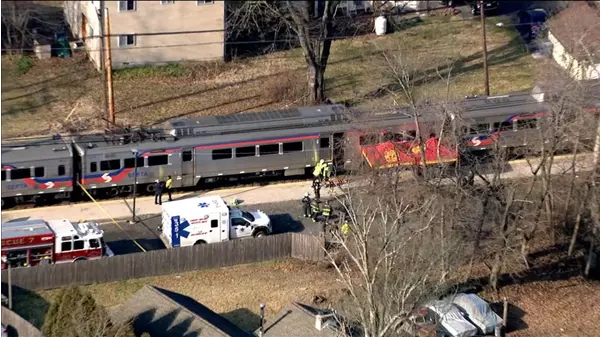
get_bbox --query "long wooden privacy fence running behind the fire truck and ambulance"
[0,233,324,290]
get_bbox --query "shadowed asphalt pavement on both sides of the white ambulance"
[99,201,332,255]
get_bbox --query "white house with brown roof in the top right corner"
[548,1,600,80]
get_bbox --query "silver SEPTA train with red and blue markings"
[0,92,592,208]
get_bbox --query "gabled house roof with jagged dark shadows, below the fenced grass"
[110,285,254,337]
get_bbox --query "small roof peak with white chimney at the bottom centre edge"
[255,302,340,337]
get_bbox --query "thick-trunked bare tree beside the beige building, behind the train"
[228,0,340,103]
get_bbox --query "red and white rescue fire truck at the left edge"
[0,219,114,269]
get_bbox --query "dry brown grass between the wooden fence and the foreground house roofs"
[15,260,341,331]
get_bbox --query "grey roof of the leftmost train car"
[0,138,73,164]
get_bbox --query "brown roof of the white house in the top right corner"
[548,1,600,61]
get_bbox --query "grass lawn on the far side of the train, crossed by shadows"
[2,17,533,138]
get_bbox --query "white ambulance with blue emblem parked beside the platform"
[159,196,272,248]
